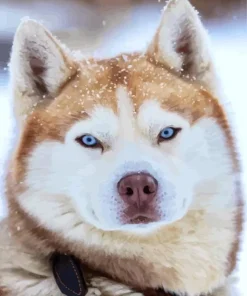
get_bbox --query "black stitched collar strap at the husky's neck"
[52,254,88,296]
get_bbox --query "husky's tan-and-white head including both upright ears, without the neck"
[6,0,242,292]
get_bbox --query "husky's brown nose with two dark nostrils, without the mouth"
[118,173,158,208]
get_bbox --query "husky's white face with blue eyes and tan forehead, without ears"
[23,74,231,232]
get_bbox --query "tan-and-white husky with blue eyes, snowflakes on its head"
[0,0,244,296]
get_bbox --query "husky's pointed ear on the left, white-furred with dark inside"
[10,20,78,119]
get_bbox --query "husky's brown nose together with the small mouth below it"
[117,173,159,224]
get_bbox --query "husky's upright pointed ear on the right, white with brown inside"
[148,0,218,91]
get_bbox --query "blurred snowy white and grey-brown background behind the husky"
[0,0,247,295]
